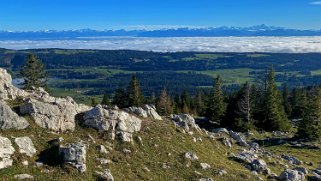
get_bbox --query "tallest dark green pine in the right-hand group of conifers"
[264,67,290,131]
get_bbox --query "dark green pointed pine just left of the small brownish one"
[127,75,144,106]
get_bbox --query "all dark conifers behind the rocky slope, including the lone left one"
[21,55,321,139]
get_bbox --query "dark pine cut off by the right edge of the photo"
[298,88,321,140]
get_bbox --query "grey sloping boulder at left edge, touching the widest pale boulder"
[0,101,29,130]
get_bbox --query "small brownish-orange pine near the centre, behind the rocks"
[156,88,173,116]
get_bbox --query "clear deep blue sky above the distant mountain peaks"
[0,0,321,31]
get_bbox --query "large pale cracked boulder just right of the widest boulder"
[83,105,142,142]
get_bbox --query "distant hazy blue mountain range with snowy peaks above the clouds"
[0,24,321,40]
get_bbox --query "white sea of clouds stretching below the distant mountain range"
[0,37,321,53]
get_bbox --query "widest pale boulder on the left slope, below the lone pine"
[20,95,89,132]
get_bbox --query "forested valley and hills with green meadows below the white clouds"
[0,49,321,95]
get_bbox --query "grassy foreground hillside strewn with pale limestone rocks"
[0,69,321,180]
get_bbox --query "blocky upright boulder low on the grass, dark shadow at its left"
[59,142,87,172]
